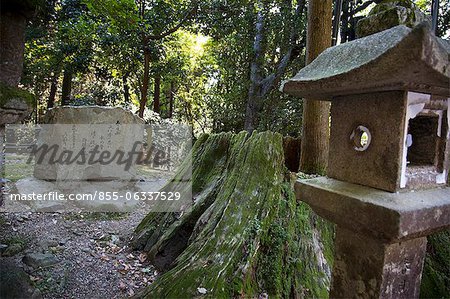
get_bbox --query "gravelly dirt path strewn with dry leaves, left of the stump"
[0,209,157,298]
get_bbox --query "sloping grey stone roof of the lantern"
[281,24,450,100]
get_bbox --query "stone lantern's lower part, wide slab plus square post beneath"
[295,177,450,298]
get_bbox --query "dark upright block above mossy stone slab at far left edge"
[0,8,26,87]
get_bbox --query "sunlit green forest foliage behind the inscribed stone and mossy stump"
[22,0,305,135]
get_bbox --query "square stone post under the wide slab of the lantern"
[330,227,427,299]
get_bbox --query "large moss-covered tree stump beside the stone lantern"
[133,132,333,298]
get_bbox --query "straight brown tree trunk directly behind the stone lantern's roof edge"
[300,0,332,173]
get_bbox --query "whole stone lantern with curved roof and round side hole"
[281,25,450,298]
